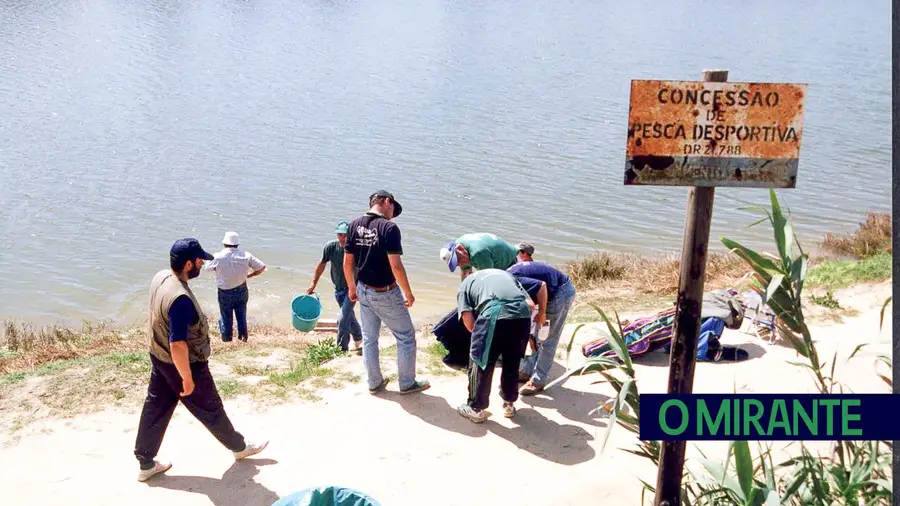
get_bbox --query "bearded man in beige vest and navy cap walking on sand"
[134,239,268,481]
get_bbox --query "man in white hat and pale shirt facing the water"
[206,232,266,343]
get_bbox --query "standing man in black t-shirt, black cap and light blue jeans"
[344,190,430,394]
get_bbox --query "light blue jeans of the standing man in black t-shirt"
[356,283,416,390]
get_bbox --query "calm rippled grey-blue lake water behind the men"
[0,0,891,324]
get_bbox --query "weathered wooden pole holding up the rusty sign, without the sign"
[653,70,728,506]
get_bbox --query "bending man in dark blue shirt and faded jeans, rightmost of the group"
[507,251,575,395]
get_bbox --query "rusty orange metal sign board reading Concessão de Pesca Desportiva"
[625,80,806,188]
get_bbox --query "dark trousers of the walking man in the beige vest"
[134,355,246,469]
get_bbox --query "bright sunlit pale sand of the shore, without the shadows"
[0,282,891,506]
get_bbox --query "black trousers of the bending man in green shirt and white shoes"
[468,318,531,411]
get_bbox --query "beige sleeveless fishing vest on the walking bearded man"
[150,269,210,364]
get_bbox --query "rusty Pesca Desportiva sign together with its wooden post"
[625,70,806,506]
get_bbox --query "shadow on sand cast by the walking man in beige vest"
[147,459,279,506]
